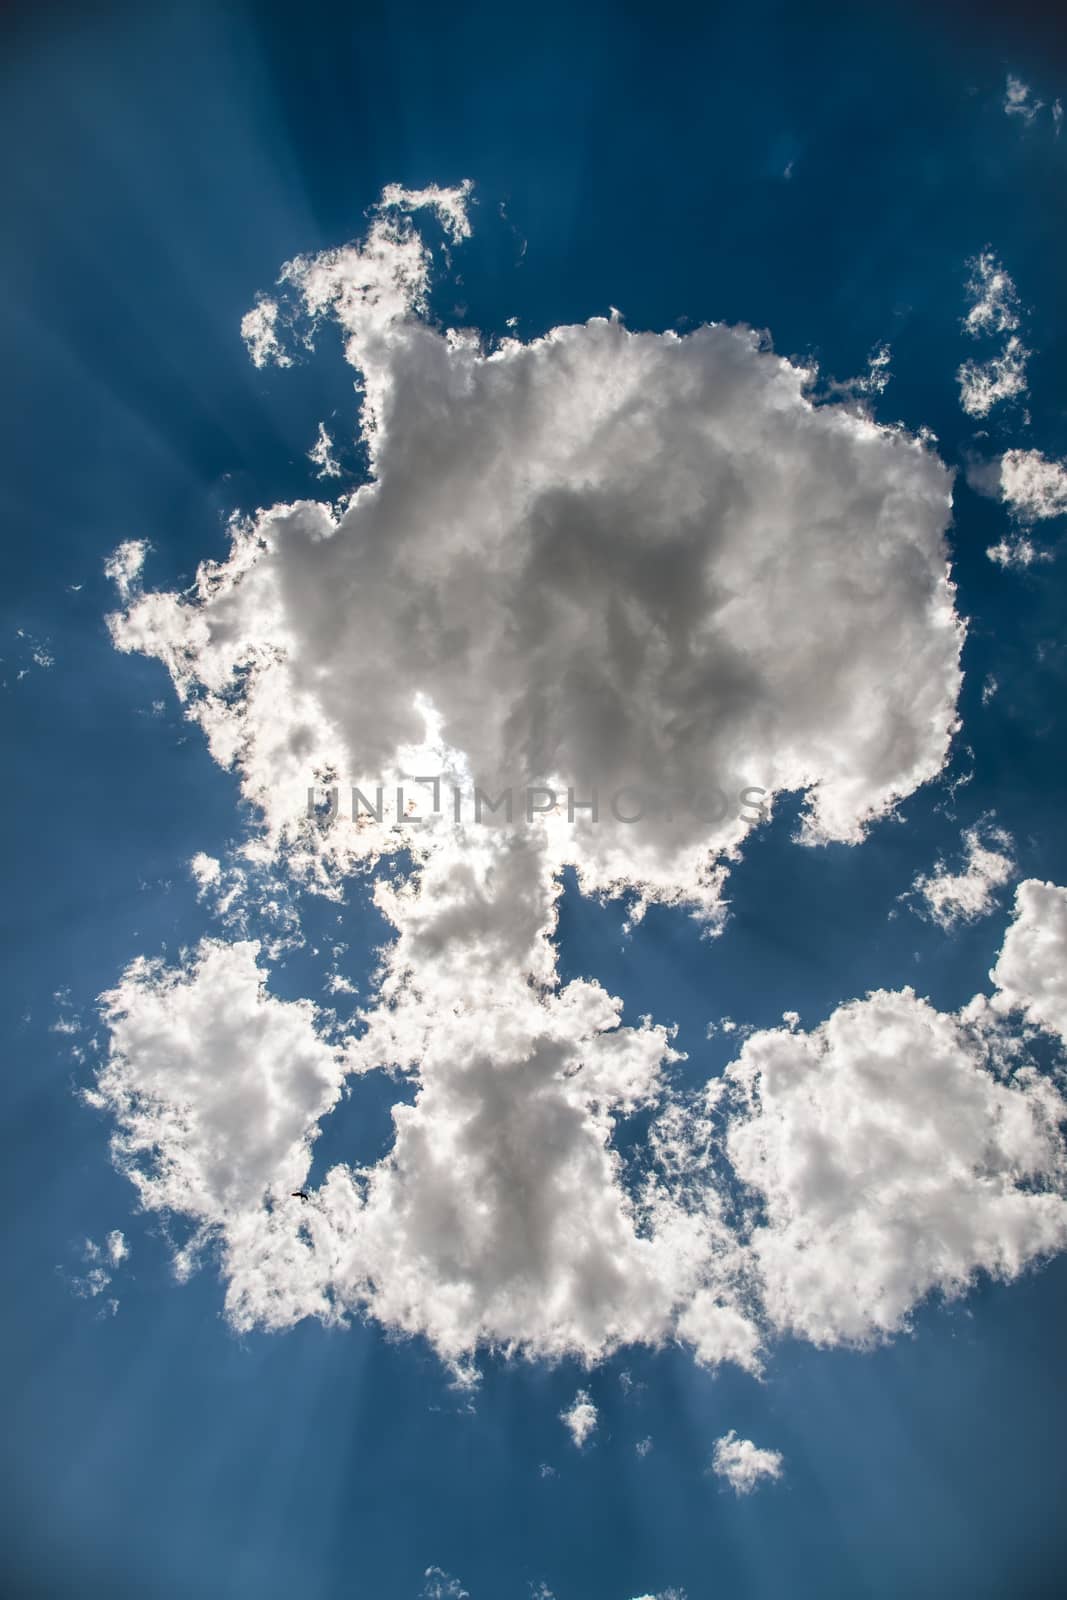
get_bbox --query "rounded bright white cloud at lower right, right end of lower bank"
[716,989,1067,1344]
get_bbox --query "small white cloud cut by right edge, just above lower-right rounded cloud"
[990,878,1067,1042]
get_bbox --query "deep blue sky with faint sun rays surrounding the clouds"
[0,5,1067,1600]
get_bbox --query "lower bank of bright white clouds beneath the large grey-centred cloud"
[89,859,1067,1369]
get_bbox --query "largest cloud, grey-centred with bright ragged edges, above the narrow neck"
[114,180,961,902]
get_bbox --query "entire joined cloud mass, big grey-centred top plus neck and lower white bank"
[96,181,1064,1378]
